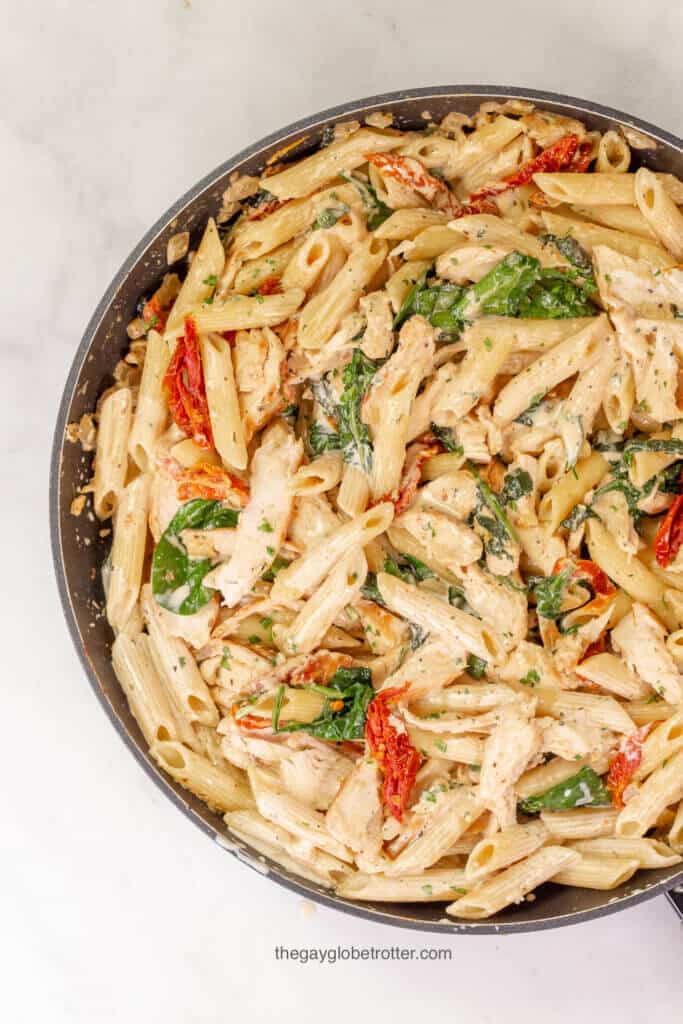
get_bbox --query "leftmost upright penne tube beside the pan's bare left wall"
[93,387,133,519]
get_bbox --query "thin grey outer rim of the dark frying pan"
[49,85,683,935]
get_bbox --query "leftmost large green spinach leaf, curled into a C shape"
[152,498,240,615]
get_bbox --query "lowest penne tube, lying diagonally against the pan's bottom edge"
[445,846,581,921]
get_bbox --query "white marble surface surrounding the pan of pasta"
[0,0,683,1024]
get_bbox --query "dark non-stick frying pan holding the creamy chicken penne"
[50,85,683,934]
